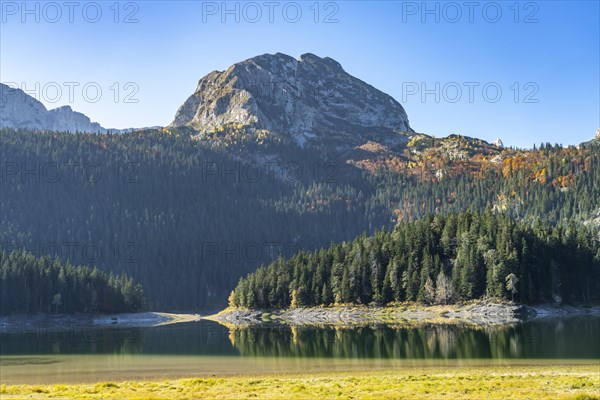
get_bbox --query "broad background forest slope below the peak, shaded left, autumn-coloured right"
[0,129,600,310]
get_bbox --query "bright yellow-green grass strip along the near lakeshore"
[0,365,600,400]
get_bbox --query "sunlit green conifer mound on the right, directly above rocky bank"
[230,211,600,308]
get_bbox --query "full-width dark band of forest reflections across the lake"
[0,317,600,359]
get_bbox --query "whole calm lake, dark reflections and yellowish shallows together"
[0,316,600,384]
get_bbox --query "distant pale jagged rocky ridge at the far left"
[0,83,107,133]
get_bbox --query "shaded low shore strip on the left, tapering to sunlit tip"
[0,311,202,333]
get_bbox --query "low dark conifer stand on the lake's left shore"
[0,249,146,315]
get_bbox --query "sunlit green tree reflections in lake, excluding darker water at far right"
[229,325,536,359]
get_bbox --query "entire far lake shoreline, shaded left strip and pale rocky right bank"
[0,301,600,333]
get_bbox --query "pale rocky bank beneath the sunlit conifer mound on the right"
[204,301,600,326]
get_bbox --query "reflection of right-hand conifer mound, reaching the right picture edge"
[229,318,600,359]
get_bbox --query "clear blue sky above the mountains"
[0,0,600,147]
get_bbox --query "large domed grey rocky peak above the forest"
[170,53,412,146]
